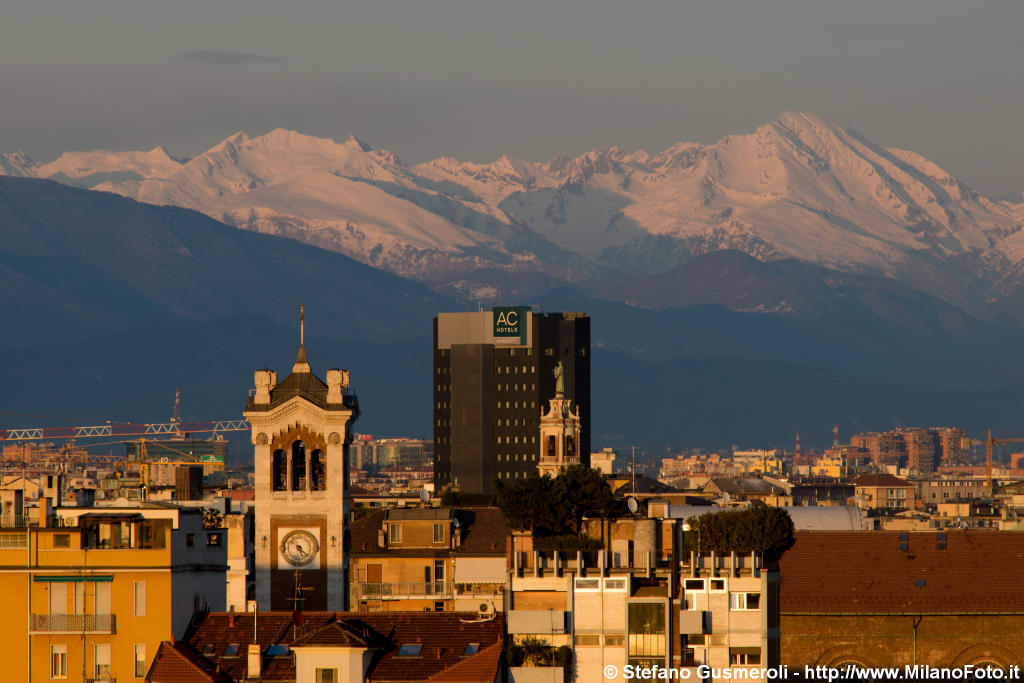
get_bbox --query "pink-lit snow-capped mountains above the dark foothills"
[8,113,1024,309]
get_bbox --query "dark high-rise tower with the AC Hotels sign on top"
[433,306,590,494]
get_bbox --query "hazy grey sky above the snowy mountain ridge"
[0,0,1024,196]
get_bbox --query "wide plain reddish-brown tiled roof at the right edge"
[778,530,1024,614]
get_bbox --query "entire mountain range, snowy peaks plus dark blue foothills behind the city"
[6,114,1024,447]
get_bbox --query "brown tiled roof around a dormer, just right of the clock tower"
[350,508,512,557]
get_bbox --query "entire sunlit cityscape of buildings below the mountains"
[9,307,1024,683]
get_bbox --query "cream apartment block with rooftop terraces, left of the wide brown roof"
[507,519,778,681]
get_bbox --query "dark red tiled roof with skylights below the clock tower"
[181,611,505,683]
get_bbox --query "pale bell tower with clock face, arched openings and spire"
[244,306,359,610]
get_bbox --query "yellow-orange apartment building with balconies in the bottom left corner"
[0,507,226,683]
